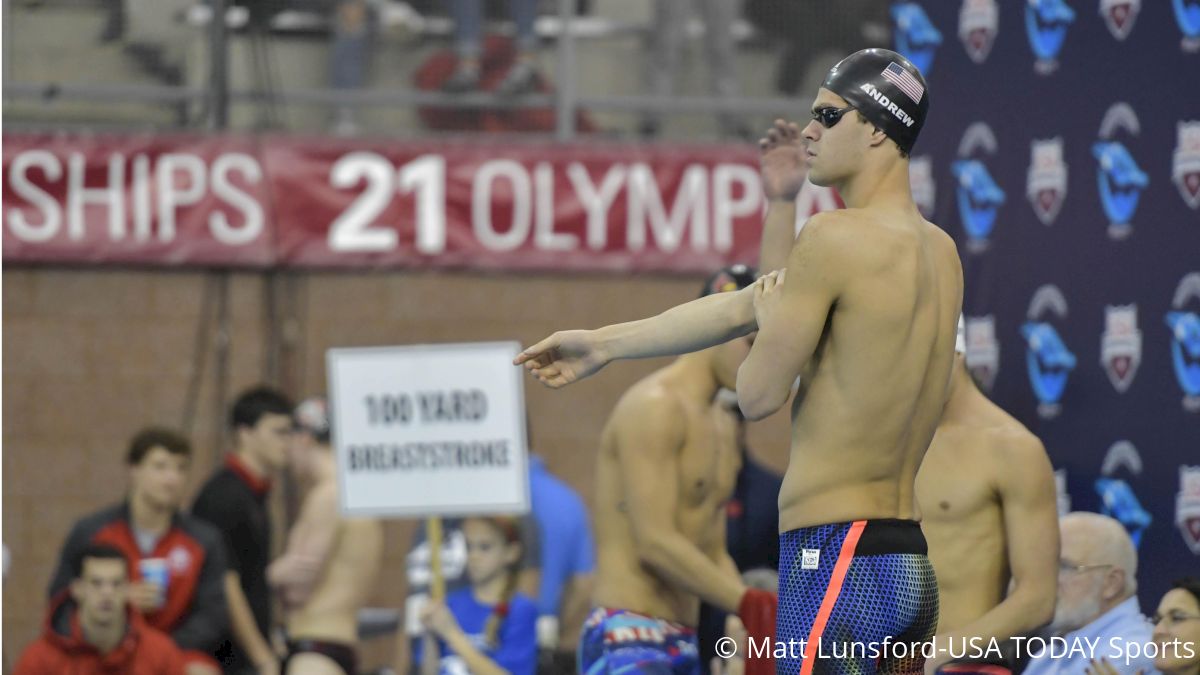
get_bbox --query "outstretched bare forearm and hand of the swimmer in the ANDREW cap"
[512,288,755,389]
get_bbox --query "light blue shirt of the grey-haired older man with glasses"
[1021,596,1158,675]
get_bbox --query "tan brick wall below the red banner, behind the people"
[2,268,787,667]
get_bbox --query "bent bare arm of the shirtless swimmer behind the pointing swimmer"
[608,392,745,613]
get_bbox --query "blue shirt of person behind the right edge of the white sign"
[529,455,595,616]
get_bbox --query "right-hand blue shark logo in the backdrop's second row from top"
[1092,103,1150,239]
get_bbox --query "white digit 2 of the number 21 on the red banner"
[329,153,400,252]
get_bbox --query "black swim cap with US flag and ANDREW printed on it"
[821,49,929,155]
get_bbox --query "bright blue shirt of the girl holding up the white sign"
[413,587,538,675]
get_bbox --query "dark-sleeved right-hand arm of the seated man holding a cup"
[170,522,229,653]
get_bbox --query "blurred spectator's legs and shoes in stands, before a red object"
[442,0,538,96]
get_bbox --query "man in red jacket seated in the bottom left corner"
[14,544,184,675]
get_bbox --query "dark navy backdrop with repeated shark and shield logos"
[892,0,1200,614]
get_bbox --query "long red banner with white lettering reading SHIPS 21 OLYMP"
[4,135,838,271]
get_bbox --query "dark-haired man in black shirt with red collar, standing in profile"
[192,387,292,675]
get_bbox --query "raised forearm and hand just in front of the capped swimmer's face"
[758,120,808,273]
